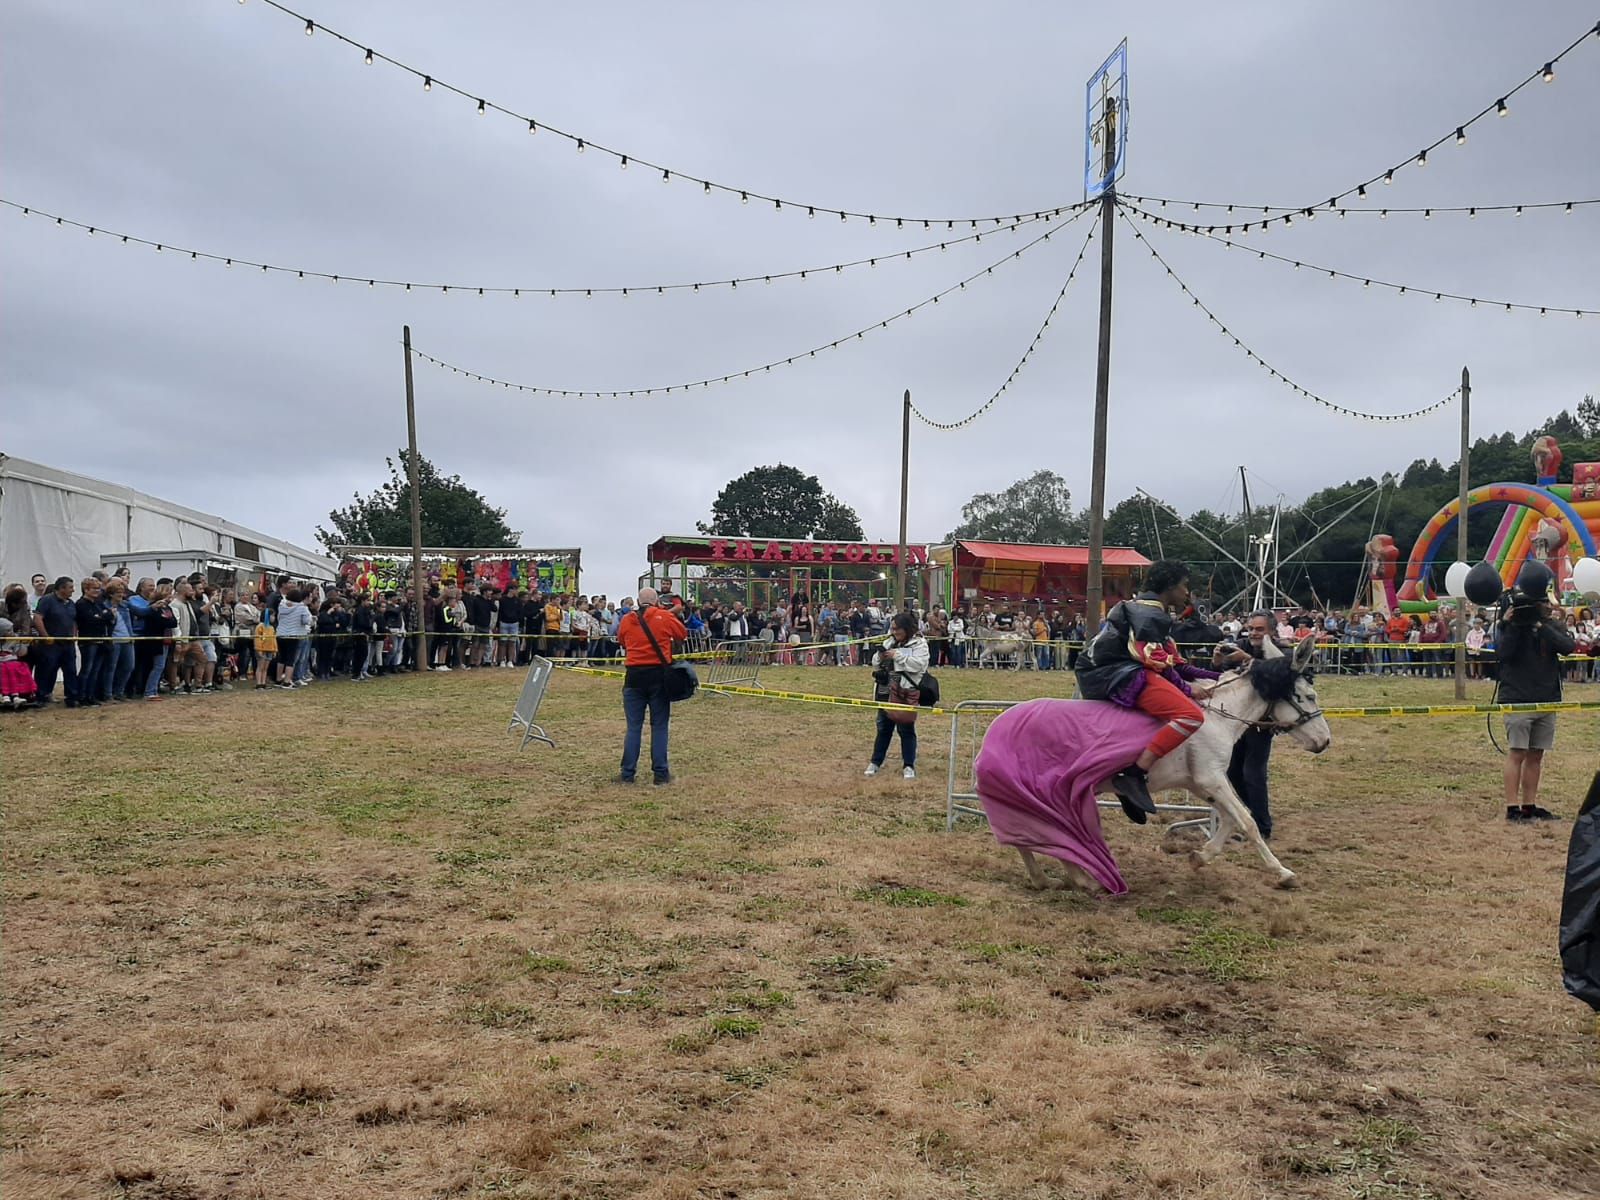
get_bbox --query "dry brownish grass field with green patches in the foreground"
[0,669,1600,1200]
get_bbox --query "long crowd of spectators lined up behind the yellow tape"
[0,571,1600,709]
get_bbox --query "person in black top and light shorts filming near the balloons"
[1494,563,1576,821]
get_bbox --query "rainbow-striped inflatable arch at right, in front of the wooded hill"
[1400,483,1600,610]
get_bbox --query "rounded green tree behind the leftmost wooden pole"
[317,450,522,549]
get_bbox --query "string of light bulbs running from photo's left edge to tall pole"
[0,198,1085,298]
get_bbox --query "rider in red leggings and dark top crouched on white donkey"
[1077,560,1248,826]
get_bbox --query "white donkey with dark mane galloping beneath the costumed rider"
[1018,638,1333,890]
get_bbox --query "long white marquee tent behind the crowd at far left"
[0,454,339,582]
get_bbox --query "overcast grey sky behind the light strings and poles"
[0,0,1600,595]
